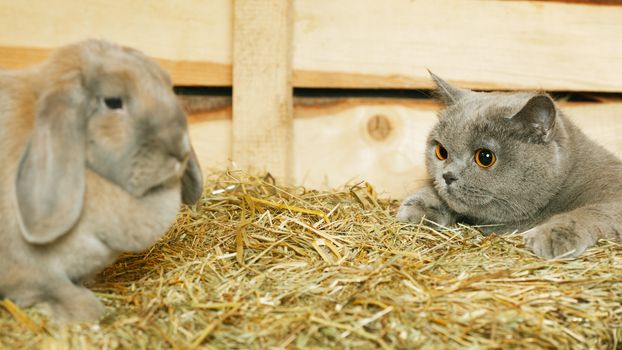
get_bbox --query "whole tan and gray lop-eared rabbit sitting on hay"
[0,40,202,321]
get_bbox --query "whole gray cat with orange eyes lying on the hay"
[397,73,622,258]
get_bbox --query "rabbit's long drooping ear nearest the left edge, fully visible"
[15,72,87,244]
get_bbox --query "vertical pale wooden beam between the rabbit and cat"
[232,0,293,182]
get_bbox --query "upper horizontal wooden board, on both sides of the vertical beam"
[0,0,622,92]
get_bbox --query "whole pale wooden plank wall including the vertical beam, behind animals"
[0,0,622,197]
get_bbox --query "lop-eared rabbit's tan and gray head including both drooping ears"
[15,40,202,244]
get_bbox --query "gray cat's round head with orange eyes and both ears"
[426,73,565,224]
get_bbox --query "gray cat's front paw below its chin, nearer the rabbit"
[396,189,454,226]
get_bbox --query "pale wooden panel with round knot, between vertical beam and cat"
[294,100,436,197]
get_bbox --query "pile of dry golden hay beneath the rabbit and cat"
[0,173,622,349]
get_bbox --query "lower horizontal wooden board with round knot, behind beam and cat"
[190,99,622,198]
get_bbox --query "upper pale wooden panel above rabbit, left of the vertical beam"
[0,0,232,85]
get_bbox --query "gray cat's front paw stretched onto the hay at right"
[524,223,590,259]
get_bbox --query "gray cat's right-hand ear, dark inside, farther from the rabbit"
[512,95,557,142]
